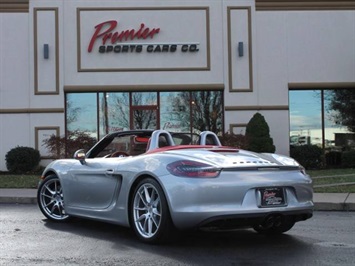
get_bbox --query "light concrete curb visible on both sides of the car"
[0,188,355,211]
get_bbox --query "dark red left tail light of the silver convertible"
[166,160,221,177]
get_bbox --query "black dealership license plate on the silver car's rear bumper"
[259,187,286,207]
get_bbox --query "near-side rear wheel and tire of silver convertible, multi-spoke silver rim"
[129,178,175,244]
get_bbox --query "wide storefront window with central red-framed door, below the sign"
[66,91,223,138]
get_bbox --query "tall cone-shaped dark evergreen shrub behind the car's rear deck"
[245,113,275,153]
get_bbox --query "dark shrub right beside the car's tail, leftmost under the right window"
[290,145,323,169]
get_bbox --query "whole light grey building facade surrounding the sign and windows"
[0,0,355,171]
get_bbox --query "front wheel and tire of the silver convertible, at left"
[37,175,69,222]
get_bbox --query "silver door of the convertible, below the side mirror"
[65,158,121,209]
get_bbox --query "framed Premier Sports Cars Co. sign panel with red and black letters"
[77,7,210,72]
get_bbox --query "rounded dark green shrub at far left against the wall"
[5,146,41,173]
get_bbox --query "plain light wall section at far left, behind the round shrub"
[0,13,33,170]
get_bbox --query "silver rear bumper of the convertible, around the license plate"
[166,172,314,229]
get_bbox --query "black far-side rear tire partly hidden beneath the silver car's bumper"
[253,215,295,235]
